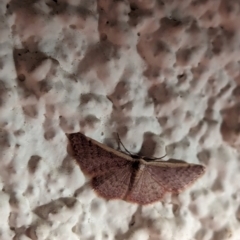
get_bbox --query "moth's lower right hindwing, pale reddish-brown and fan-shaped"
[125,165,166,205]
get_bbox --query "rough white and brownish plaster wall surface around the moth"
[0,0,240,240]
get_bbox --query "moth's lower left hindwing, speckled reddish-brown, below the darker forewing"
[92,164,132,199]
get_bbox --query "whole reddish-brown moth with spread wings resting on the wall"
[67,133,205,205]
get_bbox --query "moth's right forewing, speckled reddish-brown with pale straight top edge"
[146,161,205,193]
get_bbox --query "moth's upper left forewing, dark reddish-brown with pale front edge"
[67,132,131,177]
